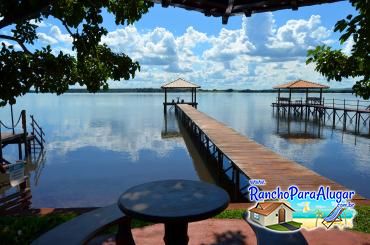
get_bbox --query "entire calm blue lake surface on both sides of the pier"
[0,93,370,207]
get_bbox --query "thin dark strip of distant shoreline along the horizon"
[30,88,353,93]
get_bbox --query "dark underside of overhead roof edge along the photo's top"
[150,0,343,24]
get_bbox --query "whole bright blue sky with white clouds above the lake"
[1,1,355,89]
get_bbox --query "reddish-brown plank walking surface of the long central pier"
[177,104,365,200]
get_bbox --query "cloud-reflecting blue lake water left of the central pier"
[0,94,199,208]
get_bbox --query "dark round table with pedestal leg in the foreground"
[118,180,230,245]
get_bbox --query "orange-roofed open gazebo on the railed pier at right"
[274,80,329,104]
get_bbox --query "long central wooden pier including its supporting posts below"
[176,104,364,200]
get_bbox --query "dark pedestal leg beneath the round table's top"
[163,223,189,245]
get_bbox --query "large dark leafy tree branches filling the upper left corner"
[0,0,153,106]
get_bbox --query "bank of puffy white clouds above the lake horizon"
[36,13,353,89]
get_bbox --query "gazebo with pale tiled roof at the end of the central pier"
[161,78,200,113]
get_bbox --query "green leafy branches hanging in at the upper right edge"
[306,0,370,99]
